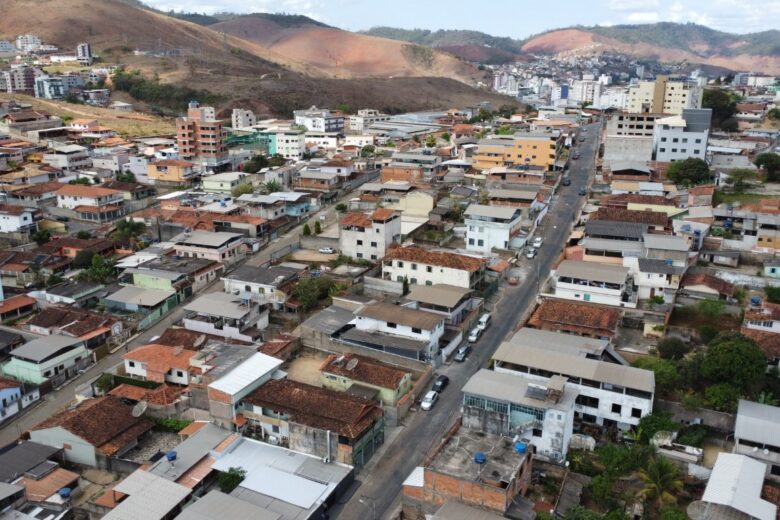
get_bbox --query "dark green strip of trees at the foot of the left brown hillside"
[111,70,222,111]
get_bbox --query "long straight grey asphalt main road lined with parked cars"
[330,124,600,520]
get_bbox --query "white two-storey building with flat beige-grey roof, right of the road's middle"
[553,260,637,307]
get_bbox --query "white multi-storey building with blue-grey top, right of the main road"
[653,108,712,162]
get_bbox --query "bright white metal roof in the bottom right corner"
[701,453,777,520]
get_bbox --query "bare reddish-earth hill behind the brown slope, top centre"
[209,13,481,82]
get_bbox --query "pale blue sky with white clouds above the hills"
[146,0,780,38]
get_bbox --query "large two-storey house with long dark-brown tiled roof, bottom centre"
[241,379,384,468]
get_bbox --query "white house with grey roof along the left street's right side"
[222,265,298,310]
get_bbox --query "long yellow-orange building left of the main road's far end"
[474,130,564,170]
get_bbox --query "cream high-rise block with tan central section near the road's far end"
[625,76,703,114]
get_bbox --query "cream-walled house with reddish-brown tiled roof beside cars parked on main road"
[320,354,412,406]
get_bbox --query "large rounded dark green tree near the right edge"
[701,332,766,390]
